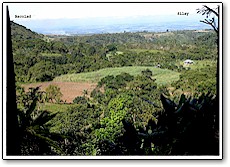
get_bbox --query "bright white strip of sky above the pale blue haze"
[8,3,217,21]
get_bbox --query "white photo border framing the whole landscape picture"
[1,1,223,160]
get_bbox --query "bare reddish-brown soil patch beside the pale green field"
[23,82,97,103]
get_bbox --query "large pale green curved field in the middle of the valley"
[54,66,180,85]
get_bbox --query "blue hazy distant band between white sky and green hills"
[11,16,210,35]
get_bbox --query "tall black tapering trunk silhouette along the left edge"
[6,6,20,155]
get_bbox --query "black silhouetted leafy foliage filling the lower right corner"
[101,95,219,155]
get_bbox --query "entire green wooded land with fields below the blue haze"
[11,22,219,155]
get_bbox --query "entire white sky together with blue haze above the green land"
[9,3,216,35]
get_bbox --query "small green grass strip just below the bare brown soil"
[38,103,77,113]
